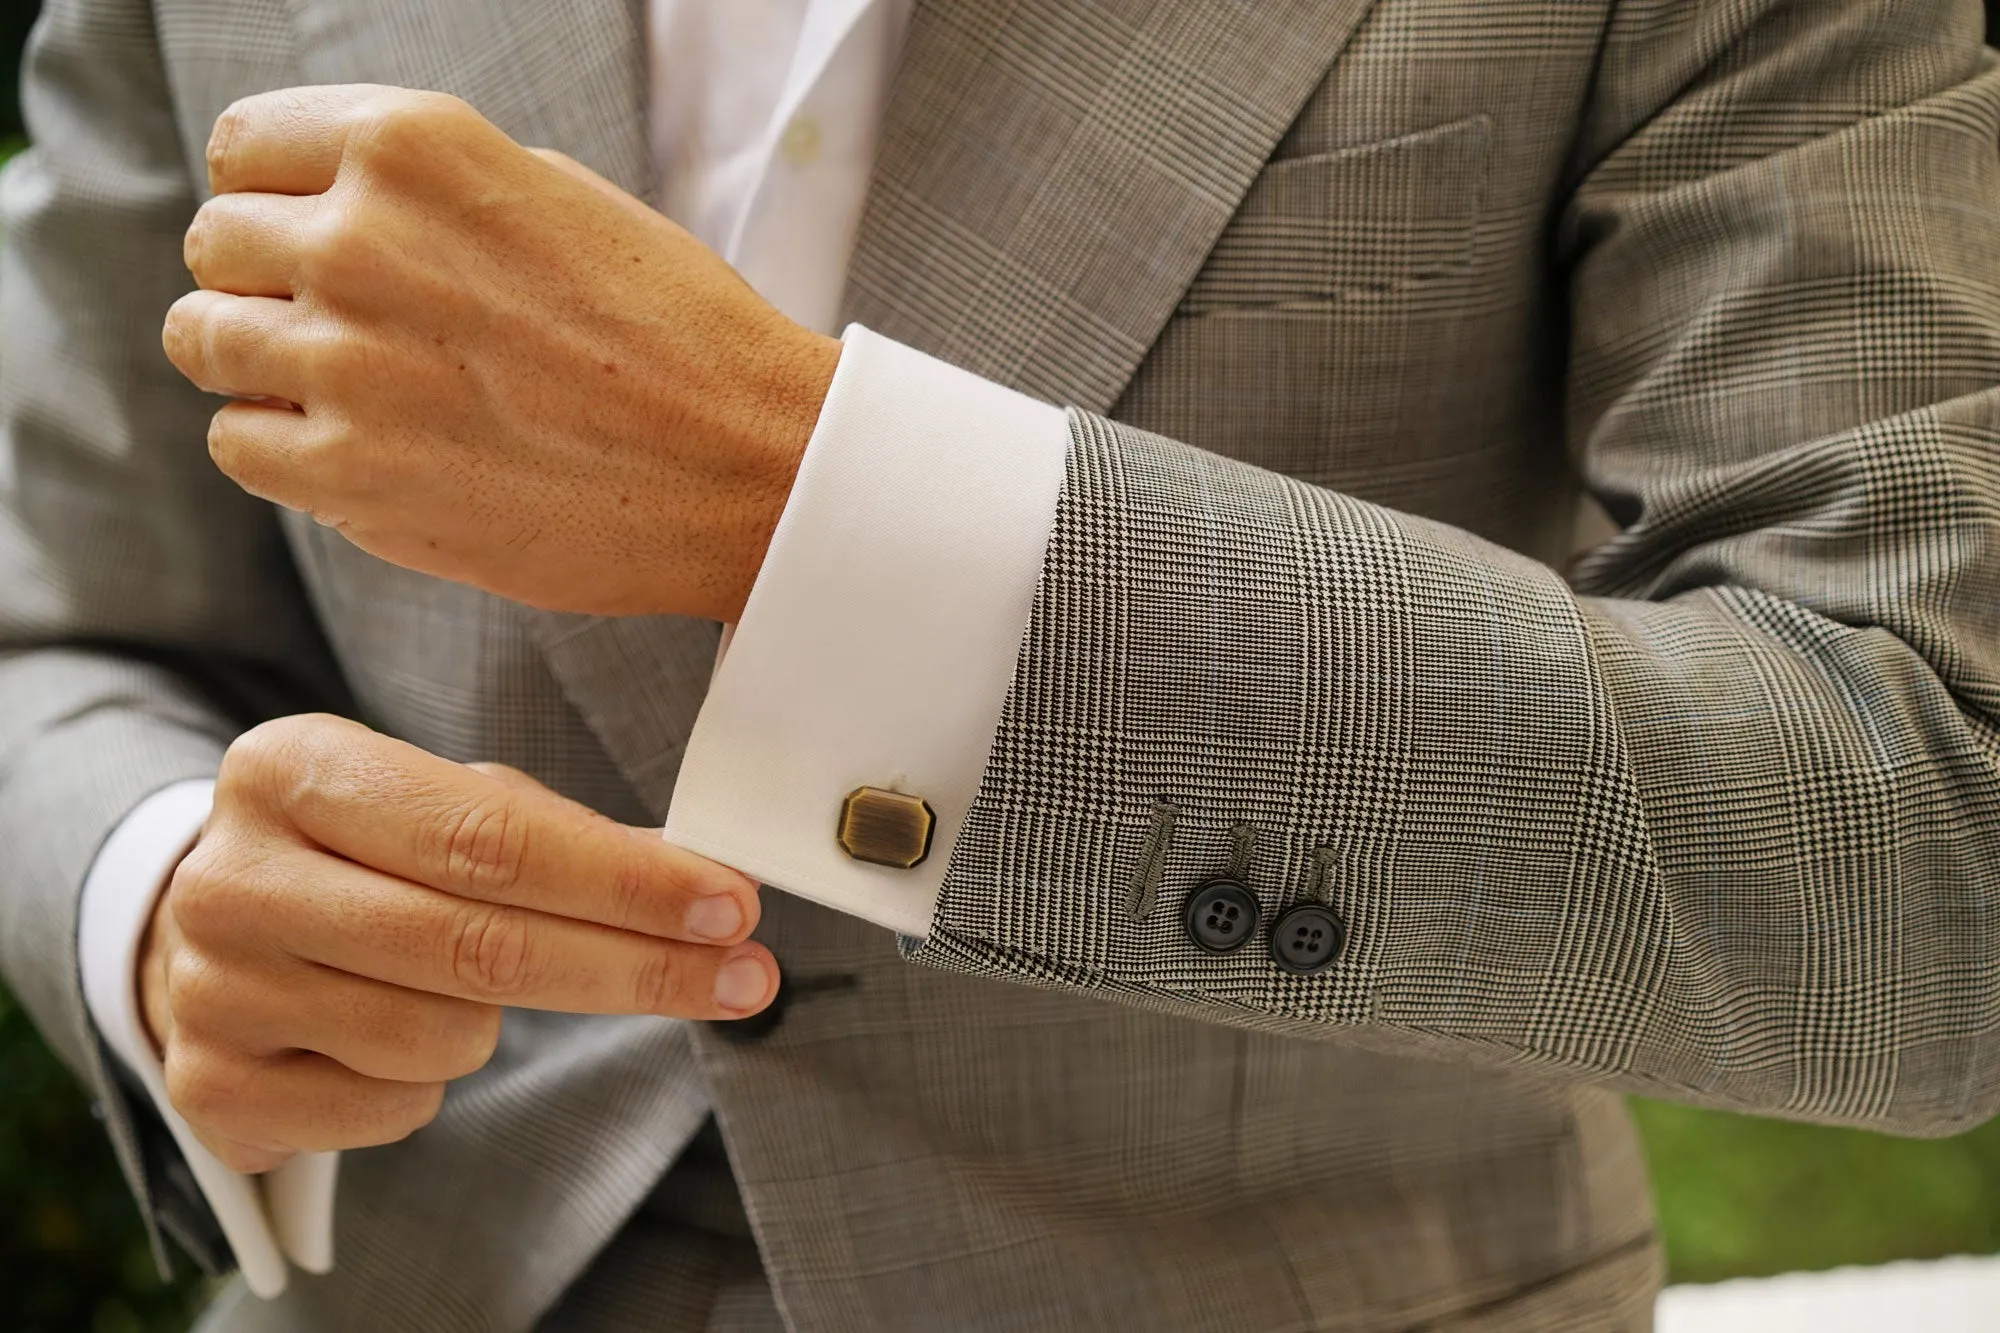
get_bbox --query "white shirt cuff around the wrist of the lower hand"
[76,781,340,1297]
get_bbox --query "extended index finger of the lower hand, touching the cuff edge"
[244,725,758,945]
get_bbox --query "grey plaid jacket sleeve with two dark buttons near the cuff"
[906,0,2000,1133]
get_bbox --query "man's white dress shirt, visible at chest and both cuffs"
[78,0,1068,1295]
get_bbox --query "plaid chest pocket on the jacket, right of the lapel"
[1180,116,1492,314]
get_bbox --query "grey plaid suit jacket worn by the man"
[0,0,2000,1331]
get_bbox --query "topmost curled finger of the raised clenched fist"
[208,84,400,194]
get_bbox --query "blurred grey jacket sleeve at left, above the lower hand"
[0,0,336,1256]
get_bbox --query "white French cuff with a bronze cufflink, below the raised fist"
[666,324,1070,937]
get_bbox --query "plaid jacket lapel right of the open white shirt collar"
[846,0,1370,412]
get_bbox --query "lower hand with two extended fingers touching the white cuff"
[140,717,778,1171]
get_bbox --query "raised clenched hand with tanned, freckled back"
[164,86,840,620]
